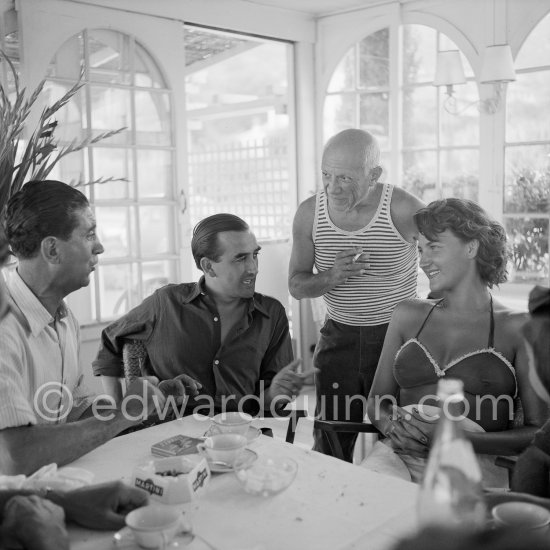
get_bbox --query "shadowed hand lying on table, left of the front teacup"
[56,481,149,530]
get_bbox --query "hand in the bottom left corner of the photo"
[0,495,69,550]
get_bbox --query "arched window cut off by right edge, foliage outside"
[504,14,550,288]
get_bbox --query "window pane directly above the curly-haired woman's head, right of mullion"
[440,149,479,202]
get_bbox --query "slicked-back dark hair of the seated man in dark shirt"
[191,213,250,270]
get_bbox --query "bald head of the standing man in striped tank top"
[321,128,382,211]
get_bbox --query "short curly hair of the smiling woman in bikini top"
[414,198,510,288]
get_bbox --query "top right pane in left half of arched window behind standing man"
[359,29,390,89]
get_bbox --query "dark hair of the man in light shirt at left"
[5,180,90,258]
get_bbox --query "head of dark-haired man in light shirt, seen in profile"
[5,180,104,296]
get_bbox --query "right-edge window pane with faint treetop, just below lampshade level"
[504,145,550,212]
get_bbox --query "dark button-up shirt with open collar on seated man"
[93,278,293,414]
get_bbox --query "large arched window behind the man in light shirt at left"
[44,29,178,321]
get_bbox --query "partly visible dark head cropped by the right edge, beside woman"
[522,286,550,405]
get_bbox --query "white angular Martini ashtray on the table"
[132,455,211,504]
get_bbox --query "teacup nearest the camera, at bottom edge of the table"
[126,504,182,549]
